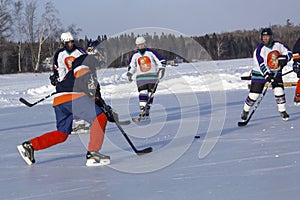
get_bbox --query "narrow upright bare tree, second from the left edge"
[13,1,25,72]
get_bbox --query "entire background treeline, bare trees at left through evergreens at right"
[0,0,300,74]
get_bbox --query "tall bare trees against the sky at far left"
[0,0,81,73]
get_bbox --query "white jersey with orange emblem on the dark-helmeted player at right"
[253,41,292,75]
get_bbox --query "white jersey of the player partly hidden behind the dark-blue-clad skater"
[53,47,86,81]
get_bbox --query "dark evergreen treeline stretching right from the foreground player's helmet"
[102,23,300,67]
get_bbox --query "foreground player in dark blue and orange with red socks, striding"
[18,55,110,166]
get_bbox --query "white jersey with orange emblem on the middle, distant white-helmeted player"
[128,48,165,76]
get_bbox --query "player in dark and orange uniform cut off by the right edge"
[293,38,300,106]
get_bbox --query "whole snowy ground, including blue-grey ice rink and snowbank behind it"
[0,59,300,200]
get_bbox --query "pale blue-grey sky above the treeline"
[37,0,300,38]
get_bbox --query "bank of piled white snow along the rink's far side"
[0,58,298,108]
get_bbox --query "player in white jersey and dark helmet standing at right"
[241,28,293,121]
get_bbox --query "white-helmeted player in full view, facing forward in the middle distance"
[127,37,166,118]
